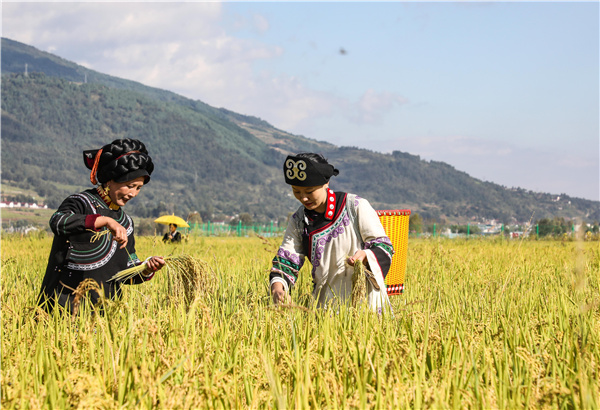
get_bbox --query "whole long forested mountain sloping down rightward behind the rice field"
[1,38,600,226]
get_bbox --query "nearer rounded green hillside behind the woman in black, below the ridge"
[2,74,291,218]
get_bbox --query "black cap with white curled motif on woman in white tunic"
[283,155,340,186]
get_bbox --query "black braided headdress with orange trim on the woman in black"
[83,138,154,185]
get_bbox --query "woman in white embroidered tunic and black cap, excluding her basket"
[270,153,394,311]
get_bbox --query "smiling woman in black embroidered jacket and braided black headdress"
[39,139,165,312]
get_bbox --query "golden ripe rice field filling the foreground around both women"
[0,235,600,409]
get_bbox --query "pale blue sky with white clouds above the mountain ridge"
[2,0,600,200]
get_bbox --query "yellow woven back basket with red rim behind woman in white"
[377,209,410,295]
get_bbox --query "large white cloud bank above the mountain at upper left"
[4,3,354,130]
